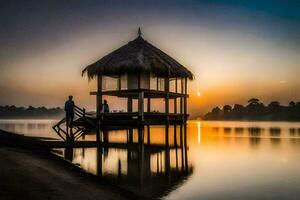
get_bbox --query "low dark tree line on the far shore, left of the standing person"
[0,105,64,119]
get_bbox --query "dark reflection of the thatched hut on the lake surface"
[93,124,193,199]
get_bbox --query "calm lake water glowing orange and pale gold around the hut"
[0,120,300,199]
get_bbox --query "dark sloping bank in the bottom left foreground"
[0,130,138,200]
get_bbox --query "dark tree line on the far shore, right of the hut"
[204,98,300,121]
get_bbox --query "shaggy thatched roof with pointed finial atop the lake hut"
[82,32,194,79]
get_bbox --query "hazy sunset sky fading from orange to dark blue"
[0,0,300,114]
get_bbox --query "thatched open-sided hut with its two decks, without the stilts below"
[82,30,193,141]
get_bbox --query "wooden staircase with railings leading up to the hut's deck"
[52,106,96,141]
